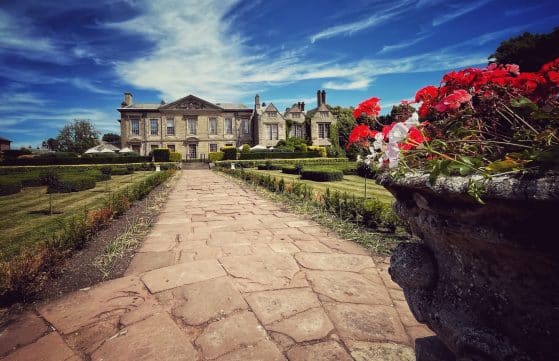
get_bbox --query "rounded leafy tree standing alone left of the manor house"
[56,119,99,153]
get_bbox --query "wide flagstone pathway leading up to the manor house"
[0,170,431,361]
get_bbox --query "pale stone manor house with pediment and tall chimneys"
[118,90,336,159]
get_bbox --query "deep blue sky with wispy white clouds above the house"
[0,0,559,147]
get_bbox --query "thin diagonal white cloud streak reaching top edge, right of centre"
[310,1,409,43]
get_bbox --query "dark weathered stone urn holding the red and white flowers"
[377,174,559,361]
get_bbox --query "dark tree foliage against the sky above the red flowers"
[489,27,559,72]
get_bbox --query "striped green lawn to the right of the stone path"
[245,169,394,203]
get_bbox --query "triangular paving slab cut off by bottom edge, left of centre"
[91,313,198,361]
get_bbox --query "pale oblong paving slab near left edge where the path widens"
[142,260,225,293]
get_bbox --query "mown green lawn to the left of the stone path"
[0,172,153,260]
